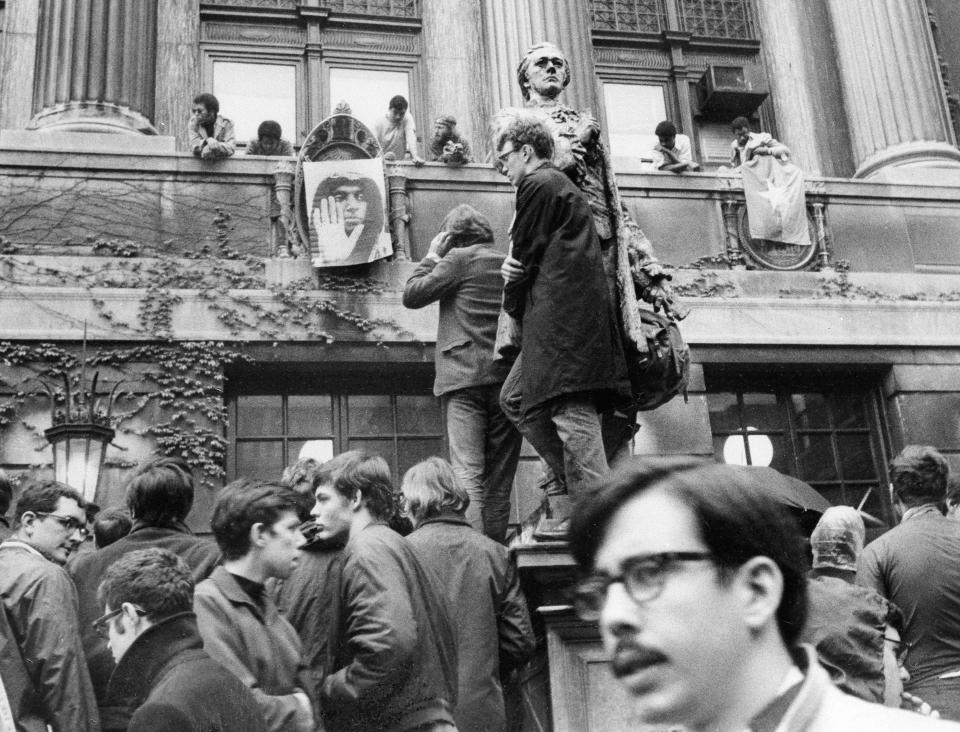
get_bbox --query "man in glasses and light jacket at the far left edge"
[0,481,100,732]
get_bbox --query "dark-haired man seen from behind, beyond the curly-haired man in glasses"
[68,457,220,732]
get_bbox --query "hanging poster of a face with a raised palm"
[303,159,393,267]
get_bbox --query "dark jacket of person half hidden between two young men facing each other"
[277,542,343,698]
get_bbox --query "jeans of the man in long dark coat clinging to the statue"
[500,354,608,500]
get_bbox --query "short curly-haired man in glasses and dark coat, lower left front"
[96,548,267,732]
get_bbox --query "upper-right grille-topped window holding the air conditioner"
[590,0,776,172]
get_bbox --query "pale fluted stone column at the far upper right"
[828,0,960,178]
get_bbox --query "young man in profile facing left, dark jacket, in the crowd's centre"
[313,450,457,732]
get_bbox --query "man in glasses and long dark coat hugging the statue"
[495,111,629,536]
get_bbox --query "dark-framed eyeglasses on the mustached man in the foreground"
[574,552,713,621]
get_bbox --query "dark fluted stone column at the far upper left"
[30,0,158,134]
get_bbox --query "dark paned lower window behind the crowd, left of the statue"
[227,387,444,479]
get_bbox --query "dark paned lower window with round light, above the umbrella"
[707,375,891,523]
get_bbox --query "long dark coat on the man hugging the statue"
[504,163,629,413]
